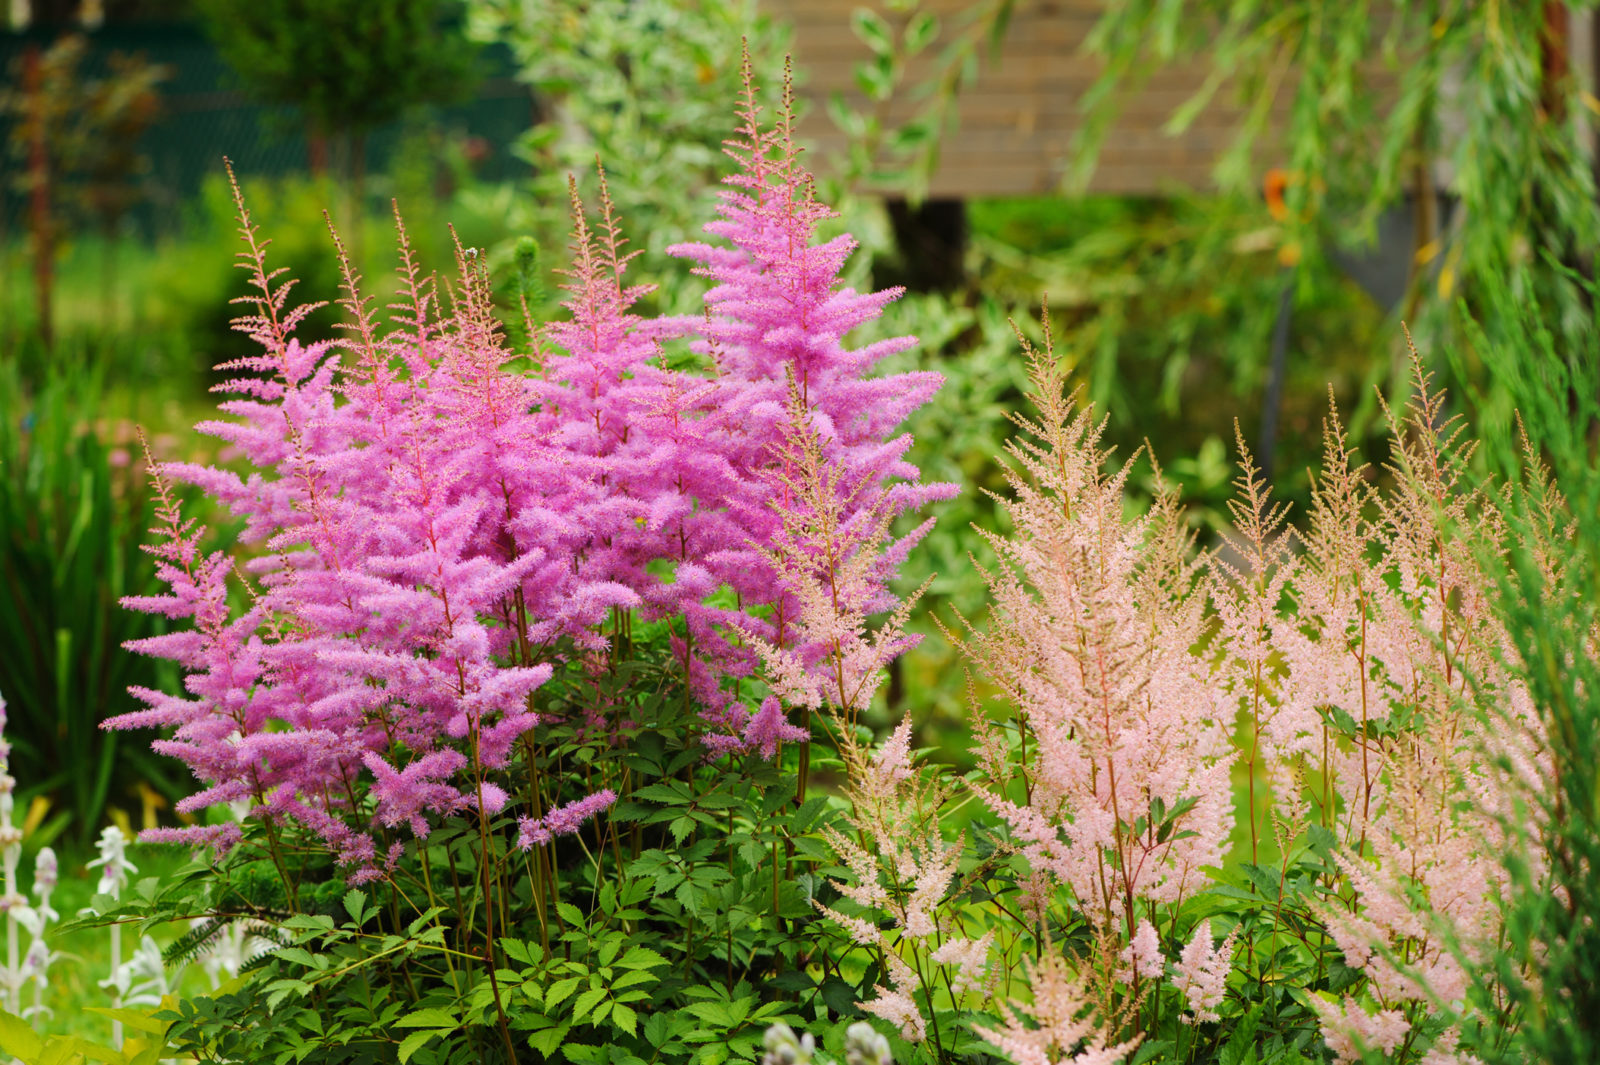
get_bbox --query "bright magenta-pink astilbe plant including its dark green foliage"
[107,59,954,1057]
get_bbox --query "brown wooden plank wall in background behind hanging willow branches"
[763,0,1288,198]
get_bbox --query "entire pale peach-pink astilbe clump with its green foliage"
[812,328,1565,1065]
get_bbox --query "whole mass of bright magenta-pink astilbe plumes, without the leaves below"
[106,70,954,880]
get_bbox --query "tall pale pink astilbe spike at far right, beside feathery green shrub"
[1292,350,1547,1062]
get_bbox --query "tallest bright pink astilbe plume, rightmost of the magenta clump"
[667,59,955,738]
